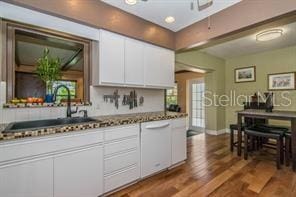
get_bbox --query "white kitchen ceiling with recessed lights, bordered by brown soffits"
[102,0,241,32]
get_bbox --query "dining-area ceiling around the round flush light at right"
[201,22,296,59]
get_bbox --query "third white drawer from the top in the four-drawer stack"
[104,150,140,174]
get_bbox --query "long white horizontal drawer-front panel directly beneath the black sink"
[0,130,103,163]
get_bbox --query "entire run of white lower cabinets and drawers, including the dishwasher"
[0,119,186,197]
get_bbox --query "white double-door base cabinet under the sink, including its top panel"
[0,129,103,197]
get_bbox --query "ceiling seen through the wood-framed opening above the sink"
[15,31,84,71]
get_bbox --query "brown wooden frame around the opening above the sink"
[1,20,92,101]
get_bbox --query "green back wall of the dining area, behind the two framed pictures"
[225,46,296,126]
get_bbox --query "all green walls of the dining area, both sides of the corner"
[176,46,296,131]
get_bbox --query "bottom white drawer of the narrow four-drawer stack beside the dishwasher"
[104,165,140,192]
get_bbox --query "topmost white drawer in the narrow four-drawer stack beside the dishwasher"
[105,124,140,141]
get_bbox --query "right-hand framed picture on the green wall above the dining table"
[268,72,296,90]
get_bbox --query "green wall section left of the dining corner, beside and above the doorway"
[176,51,225,131]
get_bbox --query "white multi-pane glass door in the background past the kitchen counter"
[189,78,205,132]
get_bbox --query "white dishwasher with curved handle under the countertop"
[141,120,172,178]
